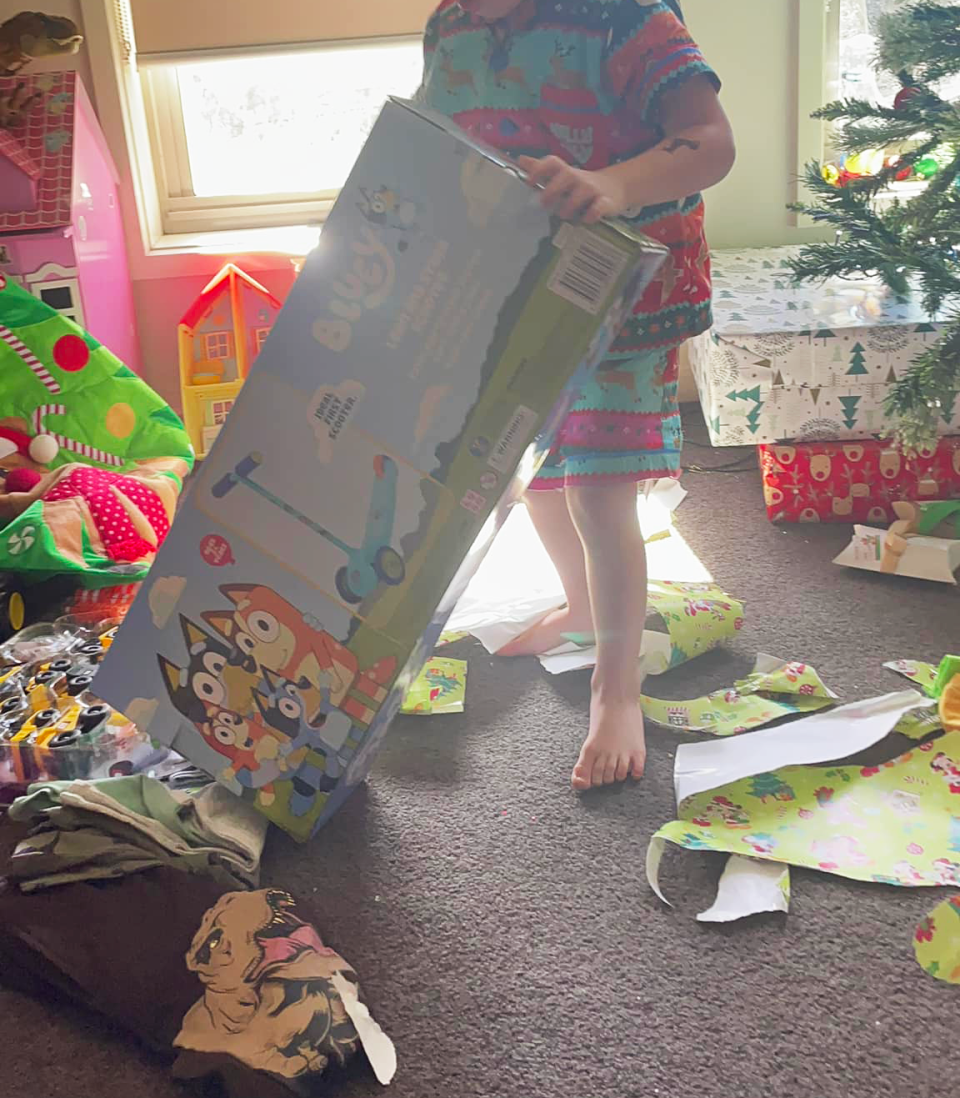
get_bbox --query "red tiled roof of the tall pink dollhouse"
[0,72,80,233]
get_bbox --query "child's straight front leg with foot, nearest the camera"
[566,482,647,789]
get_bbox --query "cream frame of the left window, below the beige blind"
[139,34,421,236]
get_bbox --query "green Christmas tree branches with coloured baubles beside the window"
[792,0,960,450]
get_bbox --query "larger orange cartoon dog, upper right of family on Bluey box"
[203,583,397,728]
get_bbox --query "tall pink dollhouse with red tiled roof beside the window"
[0,72,139,370]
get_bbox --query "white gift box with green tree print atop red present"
[688,247,960,446]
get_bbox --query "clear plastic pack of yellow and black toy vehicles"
[0,615,170,804]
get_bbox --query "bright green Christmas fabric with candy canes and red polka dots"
[0,276,193,587]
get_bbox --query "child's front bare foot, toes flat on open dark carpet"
[571,691,647,789]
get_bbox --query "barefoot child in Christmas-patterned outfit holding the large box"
[420,0,735,789]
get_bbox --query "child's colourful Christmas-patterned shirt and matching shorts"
[418,0,716,489]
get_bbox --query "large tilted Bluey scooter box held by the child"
[97,101,663,838]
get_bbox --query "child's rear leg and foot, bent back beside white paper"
[496,488,593,656]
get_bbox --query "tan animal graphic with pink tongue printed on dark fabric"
[174,889,359,1085]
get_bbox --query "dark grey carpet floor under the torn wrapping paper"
[0,412,960,1098]
